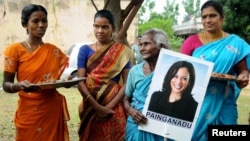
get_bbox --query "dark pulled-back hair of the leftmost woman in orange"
[21,4,48,27]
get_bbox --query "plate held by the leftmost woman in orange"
[30,77,86,89]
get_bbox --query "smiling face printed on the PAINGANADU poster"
[170,67,190,94]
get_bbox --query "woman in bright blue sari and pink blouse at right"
[181,0,250,141]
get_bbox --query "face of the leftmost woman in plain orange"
[25,11,48,38]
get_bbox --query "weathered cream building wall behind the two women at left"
[0,0,137,71]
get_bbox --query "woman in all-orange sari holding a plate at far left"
[3,4,69,141]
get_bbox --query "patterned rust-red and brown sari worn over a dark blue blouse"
[78,42,132,141]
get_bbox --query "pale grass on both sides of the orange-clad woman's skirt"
[0,87,81,141]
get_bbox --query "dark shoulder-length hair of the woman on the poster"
[162,61,195,96]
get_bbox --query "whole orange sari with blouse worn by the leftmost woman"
[4,43,69,141]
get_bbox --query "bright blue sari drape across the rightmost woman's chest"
[193,35,250,73]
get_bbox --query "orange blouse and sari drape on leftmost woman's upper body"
[4,43,68,83]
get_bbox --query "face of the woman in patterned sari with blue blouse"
[93,17,114,43]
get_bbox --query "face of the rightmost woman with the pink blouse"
[201,6,224,32]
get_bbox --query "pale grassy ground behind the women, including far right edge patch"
[0,80,250,141]
